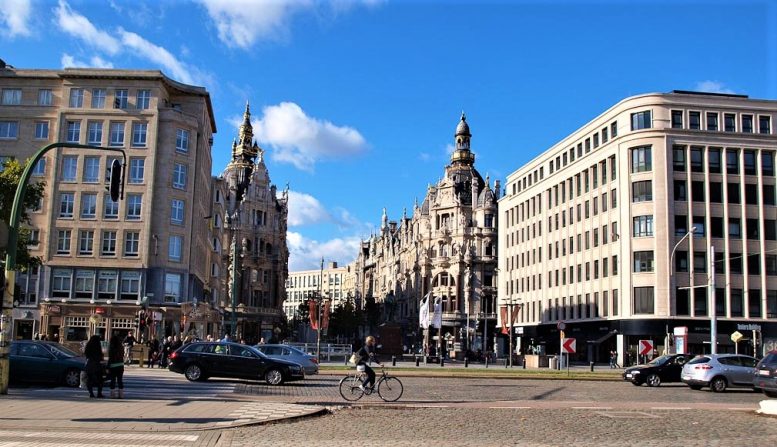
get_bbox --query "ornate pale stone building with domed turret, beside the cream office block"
[354,113,500,357]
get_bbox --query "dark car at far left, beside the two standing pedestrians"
[10,340,86,387]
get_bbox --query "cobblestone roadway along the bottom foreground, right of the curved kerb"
[223,407,777,447]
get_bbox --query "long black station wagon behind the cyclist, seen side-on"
[169,342,305,385]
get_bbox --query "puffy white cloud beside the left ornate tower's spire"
[253,102,367,171]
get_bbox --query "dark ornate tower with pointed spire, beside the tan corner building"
[211,103,289,343]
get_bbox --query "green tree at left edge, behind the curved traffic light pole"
[0,159,45,271]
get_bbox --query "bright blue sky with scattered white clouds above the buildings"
[0,0,777,271]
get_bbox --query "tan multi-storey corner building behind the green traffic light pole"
[0,65,220,344]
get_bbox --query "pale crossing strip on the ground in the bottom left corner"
[0,430,199,447]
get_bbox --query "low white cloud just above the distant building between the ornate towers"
[286,231,361,272]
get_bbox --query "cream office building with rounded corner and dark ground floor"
[498,91,777,364]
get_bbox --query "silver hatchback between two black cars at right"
[682,354,758,393]
